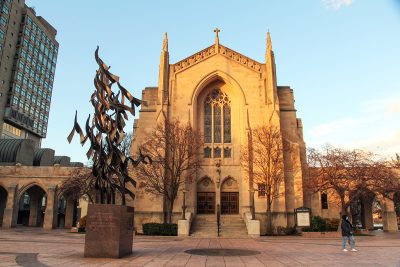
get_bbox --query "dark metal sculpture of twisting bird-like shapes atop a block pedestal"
[67,47,151,205]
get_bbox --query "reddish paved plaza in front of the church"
[0,228,400,267]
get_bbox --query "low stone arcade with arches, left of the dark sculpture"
[0,164,83,229]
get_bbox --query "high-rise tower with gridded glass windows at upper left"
[0,0,58,146]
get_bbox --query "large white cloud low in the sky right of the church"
[305,95,400,157]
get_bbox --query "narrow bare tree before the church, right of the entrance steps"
[241,125,287,233]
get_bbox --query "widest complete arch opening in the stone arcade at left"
[17,185,47,227]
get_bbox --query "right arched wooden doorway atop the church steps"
[221,177,239,214]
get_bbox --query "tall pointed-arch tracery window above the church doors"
[204,89,232,158]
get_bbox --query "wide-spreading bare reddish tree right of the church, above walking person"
[305,146,398,217]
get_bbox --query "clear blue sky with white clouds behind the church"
[26,0,400,162]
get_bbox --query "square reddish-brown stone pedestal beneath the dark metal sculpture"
[85,204,134,258]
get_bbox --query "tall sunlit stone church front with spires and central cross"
[132,29,310,232]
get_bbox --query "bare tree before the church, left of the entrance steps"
[135,120,203,223]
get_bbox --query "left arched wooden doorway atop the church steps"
[197,176,215,214]
